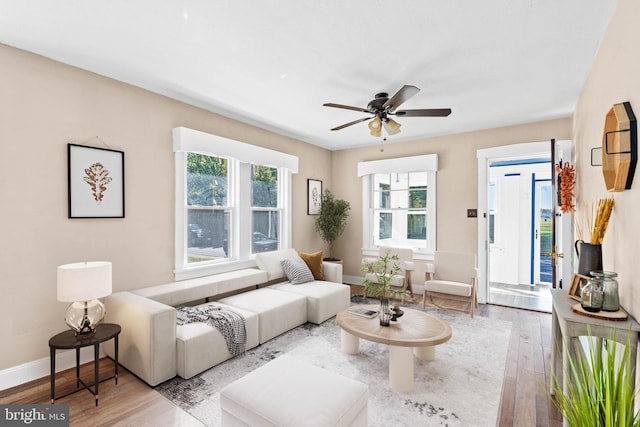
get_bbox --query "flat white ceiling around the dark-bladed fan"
[0,0,616,150]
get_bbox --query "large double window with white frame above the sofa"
[174,128,298,280]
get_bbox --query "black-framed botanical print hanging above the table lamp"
[67,144,124,218]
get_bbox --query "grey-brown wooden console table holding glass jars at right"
[551,289,640,425]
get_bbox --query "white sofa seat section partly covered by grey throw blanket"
[176,302,259,378]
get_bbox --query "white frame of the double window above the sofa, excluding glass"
[173,127,298,280]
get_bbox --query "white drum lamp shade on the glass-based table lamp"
[58,261,111,302]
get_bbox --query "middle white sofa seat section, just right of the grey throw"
[218,288,307,344]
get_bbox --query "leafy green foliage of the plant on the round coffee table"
[362,251,409,299]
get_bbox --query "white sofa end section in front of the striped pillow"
[271,280,351,324]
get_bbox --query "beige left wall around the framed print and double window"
[0,45,331,370]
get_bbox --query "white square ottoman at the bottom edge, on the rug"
[220,355,369,427]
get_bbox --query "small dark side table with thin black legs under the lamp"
[49,323,121,406]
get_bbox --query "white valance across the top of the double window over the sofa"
[173,127,298,173]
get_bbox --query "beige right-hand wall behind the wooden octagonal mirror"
[573,0,640,318]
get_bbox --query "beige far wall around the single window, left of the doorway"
[333,119,571,279]
